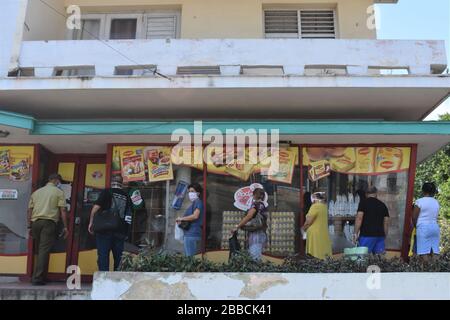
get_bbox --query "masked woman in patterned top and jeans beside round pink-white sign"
[231,188,268,261]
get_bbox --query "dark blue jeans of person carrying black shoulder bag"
[95,233,125,271]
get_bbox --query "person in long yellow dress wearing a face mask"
[302,192,332,259]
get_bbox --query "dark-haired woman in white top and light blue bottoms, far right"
[413,182,440,258]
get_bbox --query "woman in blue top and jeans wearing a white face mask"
[176,183,204,257]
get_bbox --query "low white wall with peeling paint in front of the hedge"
[91,272,450,300]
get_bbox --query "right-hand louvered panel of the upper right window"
[300,10,336,39]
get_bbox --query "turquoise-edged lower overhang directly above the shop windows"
[0,112,450,162]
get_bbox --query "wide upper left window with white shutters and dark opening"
[71,11,180,40]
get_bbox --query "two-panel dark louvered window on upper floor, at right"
[264,9,336,39]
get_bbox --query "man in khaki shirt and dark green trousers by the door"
[28,174,68,285]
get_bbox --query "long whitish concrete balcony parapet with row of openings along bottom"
[10,39,447,77]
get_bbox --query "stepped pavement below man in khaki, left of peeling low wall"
[0,277,92,300]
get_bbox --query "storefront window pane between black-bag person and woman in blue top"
[112,146,203,252]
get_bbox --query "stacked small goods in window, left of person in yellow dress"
[267,212,295,255]
